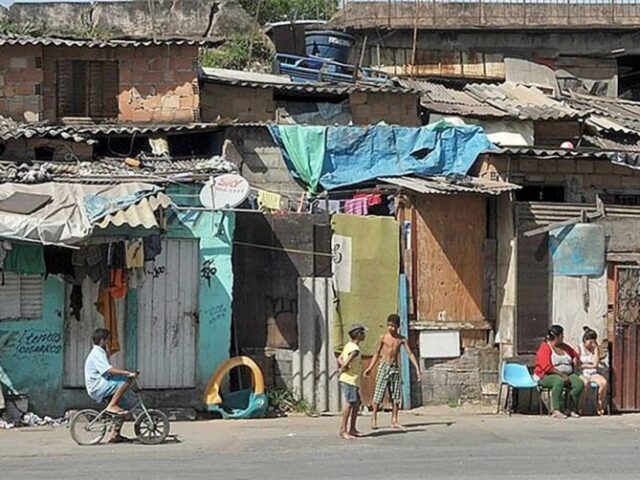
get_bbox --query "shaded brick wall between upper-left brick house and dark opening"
[201,83,276,122]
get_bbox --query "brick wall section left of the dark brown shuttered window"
[0,45,43,122]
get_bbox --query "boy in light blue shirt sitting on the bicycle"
[84,328,138,443]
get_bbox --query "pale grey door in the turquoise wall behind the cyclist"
[137,240,200,388]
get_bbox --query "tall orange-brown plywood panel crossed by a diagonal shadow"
[414,195,486,323]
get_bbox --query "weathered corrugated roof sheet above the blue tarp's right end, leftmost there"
[397,79,509,117]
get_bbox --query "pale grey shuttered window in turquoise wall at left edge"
[0,272,42,320]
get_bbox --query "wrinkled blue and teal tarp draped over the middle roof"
[270,125,494,192]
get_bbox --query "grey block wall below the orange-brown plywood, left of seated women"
[420,347,499,405]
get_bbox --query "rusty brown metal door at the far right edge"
[612,266,640,412]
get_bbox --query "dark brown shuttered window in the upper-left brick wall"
[57,60,118,118]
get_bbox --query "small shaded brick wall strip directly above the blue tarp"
[349,92,421,127]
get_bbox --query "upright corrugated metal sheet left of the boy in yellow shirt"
[292,278,342,413]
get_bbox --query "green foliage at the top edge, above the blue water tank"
[240,0,338,25]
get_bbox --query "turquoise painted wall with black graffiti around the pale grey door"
[0,191,235,415]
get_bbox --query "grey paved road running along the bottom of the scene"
[0,409,640,480]
